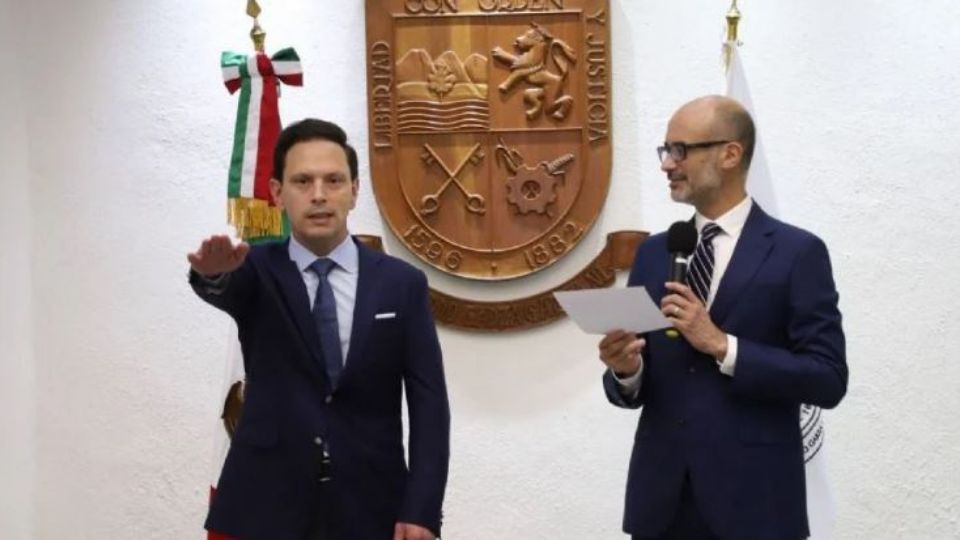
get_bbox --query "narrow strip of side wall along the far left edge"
[0,0,37,538]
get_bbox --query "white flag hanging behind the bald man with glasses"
[724,43,836,540]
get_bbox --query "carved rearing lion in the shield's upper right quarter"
[492,23,577,120]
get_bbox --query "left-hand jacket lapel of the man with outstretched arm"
[267,238,326,380]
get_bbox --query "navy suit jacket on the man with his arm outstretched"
[191,242,450,540]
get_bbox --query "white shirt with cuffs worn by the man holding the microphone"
[611,197,753,390]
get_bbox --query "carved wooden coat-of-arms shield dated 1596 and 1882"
[366,0,611,280]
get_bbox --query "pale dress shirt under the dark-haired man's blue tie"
[288,234,360,365]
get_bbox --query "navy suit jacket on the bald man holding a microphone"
[604,204,847,540]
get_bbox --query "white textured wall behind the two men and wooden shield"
[7,0,960,540]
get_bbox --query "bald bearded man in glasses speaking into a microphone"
[599,96,847,540]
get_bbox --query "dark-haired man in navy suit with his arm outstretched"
[188,119,450,540]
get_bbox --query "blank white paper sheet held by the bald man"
[553,287,671,334]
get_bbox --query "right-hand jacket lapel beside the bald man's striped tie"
[710,203,773,328]
